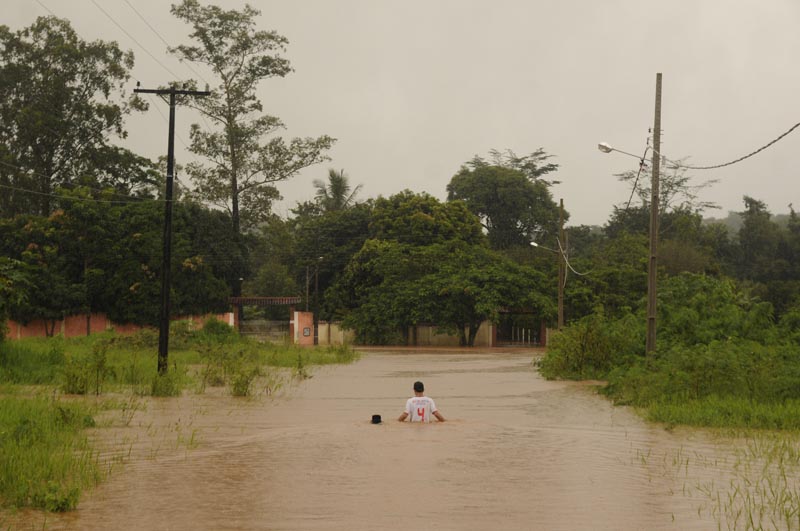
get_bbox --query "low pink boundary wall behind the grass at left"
[6,312,236,339]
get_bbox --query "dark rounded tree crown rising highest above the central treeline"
[447,153,569,249]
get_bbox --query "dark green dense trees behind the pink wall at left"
[0,196,236,326]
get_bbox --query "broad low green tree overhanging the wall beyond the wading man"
[333,239,554,346]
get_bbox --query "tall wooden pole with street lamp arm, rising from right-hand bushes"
[645,72,661,354]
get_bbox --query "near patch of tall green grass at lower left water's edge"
[0,396,102,511]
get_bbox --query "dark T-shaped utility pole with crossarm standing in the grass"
[133,83,211,375]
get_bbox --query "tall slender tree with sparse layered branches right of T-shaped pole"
[170,0,334,234]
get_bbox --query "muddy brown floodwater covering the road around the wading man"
[7,350,800,531]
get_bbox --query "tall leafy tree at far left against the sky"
[0,17,157,216]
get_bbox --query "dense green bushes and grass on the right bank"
[540,273,800,429]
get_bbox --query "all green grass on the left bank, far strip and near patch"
[0,324,358,511]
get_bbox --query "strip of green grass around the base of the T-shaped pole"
[0,325,359,395]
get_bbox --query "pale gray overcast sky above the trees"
[6,0,800,224]
